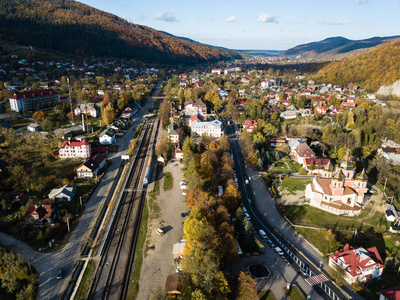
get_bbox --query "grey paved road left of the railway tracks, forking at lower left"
[0,85,159,300]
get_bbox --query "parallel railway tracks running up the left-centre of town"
[88,119,159,299]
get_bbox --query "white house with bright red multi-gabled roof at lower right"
[329,244,384,284]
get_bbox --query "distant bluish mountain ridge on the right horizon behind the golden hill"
[280,36,400,59]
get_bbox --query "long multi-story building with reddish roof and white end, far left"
[9,89,61,112]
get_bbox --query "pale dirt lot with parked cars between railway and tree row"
[137,162,188,299]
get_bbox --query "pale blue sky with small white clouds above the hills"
[79,0,400,50]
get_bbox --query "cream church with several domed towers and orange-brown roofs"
[305,150,368,216]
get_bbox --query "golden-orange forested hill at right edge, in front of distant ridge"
[316,40,400,91]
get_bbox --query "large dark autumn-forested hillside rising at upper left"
[0,0,241,64]
